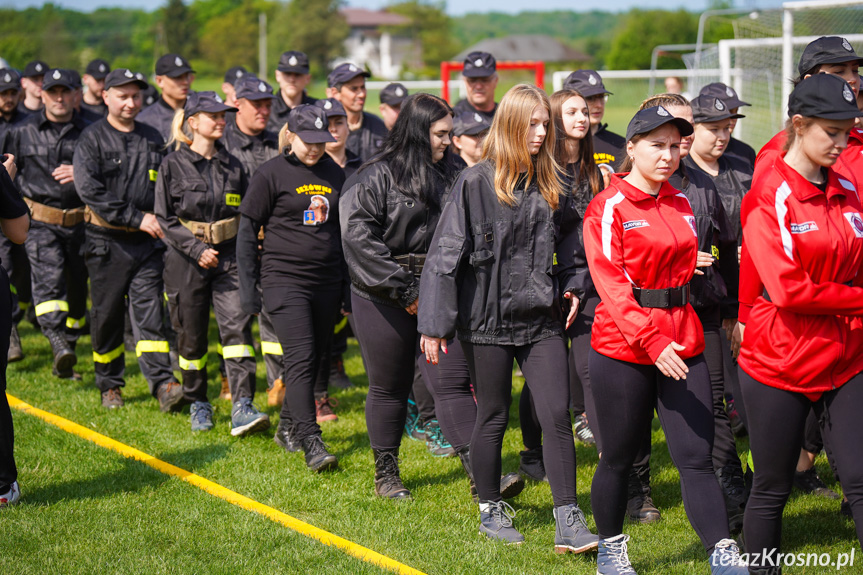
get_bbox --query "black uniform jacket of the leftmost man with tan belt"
[4,110,87,209]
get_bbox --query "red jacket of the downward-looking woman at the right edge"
[739,157,863,400]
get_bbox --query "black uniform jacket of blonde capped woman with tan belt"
[156,143,248,262]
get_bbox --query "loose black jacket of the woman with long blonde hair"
[418,161,578,345]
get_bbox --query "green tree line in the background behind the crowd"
[0,0,733,77]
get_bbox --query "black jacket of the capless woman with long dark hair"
[339,161,445,307]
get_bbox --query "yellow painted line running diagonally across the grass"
[6,393,425,575]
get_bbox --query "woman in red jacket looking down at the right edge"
[739,74,863,574]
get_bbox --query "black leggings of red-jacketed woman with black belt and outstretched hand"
[590,351,729,551]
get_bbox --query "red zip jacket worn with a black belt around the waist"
[584,174,704,365]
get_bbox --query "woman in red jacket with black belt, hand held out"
[584,106,746,575]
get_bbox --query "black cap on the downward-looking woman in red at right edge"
[788,74,863,120]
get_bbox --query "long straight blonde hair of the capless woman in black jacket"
[482,84,563,210]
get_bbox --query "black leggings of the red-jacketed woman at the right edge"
[739,369,863,556]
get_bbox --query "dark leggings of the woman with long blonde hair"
[462,335,576,507]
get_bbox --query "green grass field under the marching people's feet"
[5,322,863,575]
